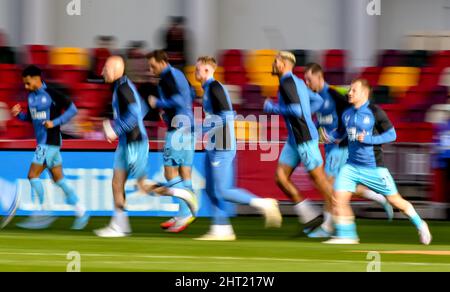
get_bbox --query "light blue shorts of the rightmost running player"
[334,164,398,196]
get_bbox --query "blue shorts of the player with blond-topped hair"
[278,140,323,171]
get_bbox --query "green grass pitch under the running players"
[0,217,450,272]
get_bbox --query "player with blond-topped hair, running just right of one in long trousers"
[264,52,333,231]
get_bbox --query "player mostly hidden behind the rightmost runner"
[304,63,394,238]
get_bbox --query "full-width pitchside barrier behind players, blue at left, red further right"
[0,140,446,218]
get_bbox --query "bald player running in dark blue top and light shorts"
[94,56,149,237]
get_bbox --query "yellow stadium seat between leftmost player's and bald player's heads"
[50,48,90,68]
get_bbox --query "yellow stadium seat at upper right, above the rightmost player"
[378,67,420,97]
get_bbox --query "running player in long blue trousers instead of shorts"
[195,56,282,240]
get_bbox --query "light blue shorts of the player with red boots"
[163,130,195,167]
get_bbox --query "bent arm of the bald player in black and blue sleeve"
[112,84,140,136]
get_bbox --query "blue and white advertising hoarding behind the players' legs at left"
[0,151,235,217]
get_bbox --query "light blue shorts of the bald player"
[114,140,148,179]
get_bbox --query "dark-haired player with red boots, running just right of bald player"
[147,50,196,233]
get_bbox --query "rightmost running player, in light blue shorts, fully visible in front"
[323,79,431,245]
